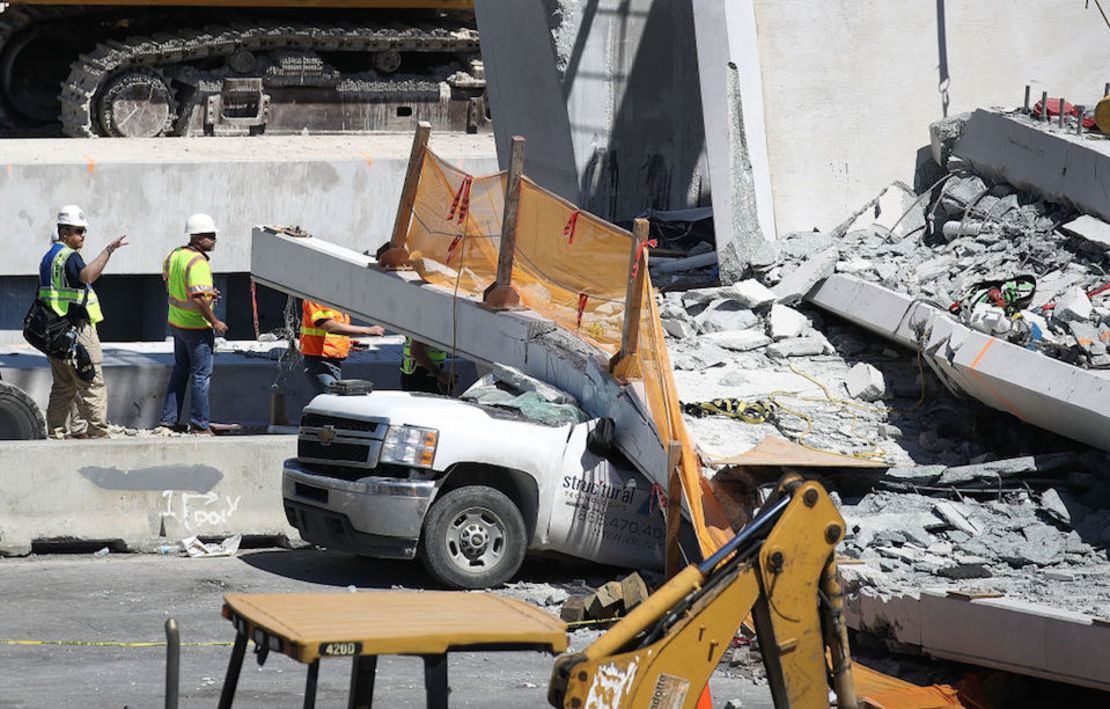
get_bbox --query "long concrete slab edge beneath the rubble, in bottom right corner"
[840,581,1110,691]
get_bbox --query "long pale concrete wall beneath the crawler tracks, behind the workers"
[0,133,497,278]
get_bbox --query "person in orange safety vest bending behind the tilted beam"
[301,301,385,394]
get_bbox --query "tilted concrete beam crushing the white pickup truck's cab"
[251,227,667,485]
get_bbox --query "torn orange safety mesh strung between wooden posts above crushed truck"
[405,150,733,556]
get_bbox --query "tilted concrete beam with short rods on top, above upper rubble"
[952,110,1110,221]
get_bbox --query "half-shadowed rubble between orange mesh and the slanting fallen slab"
[659,280,1025,465]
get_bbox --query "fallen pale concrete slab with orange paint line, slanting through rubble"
[809,274,1110,450]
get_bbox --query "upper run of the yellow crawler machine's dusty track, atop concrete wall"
[60,16,478,138]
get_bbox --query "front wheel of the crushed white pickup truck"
[420,485,527,588]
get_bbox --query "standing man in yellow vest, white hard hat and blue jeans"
[159,213,228,436]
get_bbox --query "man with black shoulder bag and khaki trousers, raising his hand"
[38,204,128,438]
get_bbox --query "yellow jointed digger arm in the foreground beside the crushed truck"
[548,475,857,709]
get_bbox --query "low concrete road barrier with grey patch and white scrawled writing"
[0,436,296,555]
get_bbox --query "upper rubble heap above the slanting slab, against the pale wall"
[763,115,1110,368]
